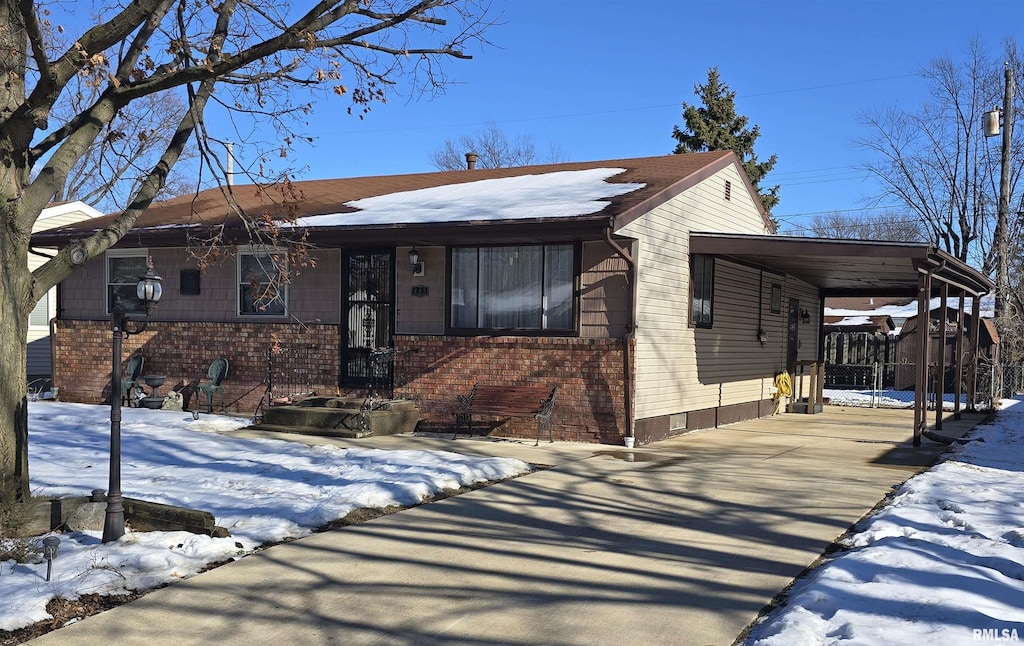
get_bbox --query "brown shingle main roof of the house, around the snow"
[36,152,767,243]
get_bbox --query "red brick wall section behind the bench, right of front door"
[394,336,626,444]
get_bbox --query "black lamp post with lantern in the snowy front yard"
[102,256,164,543]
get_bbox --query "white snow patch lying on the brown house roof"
[296,168,646,226]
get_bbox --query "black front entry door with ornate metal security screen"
[341,250,394,387]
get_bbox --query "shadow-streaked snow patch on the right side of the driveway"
[743,402,1024,646]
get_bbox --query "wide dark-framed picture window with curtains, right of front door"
[451,245,575,332]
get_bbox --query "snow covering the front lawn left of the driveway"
[0,402,529,631]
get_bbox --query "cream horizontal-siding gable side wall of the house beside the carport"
[618,166,817,420]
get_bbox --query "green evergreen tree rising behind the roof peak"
[672,68,778,217]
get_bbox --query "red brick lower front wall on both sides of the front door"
[53,320,626,444]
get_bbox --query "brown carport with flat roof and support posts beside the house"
[690,231,993,446]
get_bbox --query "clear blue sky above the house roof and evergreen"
[211,0,1024,235]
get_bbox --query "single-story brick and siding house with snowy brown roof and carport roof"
[35,153,990,443]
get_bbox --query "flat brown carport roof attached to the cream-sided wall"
[690,232,993,297]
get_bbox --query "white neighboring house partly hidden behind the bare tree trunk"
[27,202,103,390]
